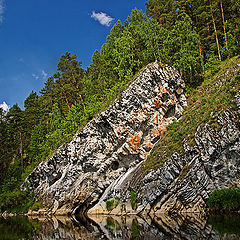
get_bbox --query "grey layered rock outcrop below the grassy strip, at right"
[88,64,240,216]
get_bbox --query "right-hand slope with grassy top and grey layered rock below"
[88,59,240,215]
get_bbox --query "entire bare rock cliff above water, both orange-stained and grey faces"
[24,59,240,215]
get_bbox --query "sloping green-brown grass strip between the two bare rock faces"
[143,57,240,173]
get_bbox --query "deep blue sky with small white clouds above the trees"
[0,0,146,110]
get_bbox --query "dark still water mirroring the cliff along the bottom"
[0,215,240,240]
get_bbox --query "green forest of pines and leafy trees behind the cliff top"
[0,0,240,211]
